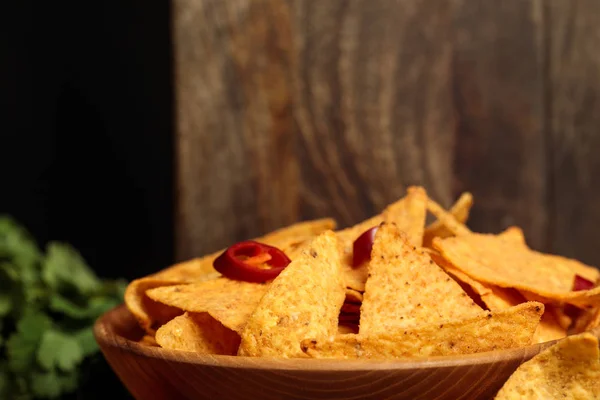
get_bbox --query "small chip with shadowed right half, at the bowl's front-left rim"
[156,312,240,355]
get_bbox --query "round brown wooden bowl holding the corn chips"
[94,305,588,400]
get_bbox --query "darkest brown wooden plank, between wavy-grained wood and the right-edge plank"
[454,0,548,248]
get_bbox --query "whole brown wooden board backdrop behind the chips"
[172,0,600,265]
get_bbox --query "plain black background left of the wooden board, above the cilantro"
[0,0,173,399]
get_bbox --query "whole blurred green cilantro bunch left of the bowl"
[0,216,126,400]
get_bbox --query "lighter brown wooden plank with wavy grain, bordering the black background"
[174,0,454,259]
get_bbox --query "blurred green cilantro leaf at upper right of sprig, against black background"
[42,242,101,295]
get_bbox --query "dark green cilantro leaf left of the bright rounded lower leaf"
[6,312,52,373]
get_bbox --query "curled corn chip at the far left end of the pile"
[125,278,183,334]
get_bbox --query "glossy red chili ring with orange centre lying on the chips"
[213,240,291,282]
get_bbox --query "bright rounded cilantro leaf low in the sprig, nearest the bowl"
[37,329,83,371]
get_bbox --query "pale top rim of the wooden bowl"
[93,304,580,372]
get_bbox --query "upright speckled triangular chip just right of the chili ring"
[238,231,346,358]
